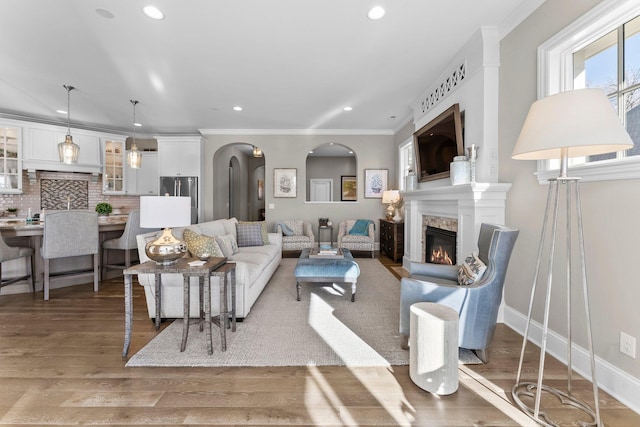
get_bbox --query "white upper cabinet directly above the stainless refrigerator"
[157,136,202,177]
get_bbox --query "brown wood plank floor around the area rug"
[0,257,640,426]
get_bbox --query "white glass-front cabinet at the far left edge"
[0,123,22,194]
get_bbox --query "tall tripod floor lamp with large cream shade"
[511,89,633,426]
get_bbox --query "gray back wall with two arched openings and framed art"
[203,135,398,241]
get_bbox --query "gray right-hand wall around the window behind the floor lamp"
[499,0,640,377]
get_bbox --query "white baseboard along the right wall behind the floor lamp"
[504,306,640,414]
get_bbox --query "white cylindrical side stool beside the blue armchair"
[409,302,458,395]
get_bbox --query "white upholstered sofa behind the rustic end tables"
[137,218,282,318]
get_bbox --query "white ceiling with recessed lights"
[0,0,540,136]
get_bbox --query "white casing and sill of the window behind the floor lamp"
[536,0,640,184]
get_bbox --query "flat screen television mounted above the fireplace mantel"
[413,104,464,182]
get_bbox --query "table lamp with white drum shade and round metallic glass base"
[140,196,191,265]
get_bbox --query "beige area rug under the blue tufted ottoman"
[127,258,477,367]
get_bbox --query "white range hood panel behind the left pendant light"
[22,124,102,174]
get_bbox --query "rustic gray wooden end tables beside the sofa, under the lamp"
[122,258,235,359]
